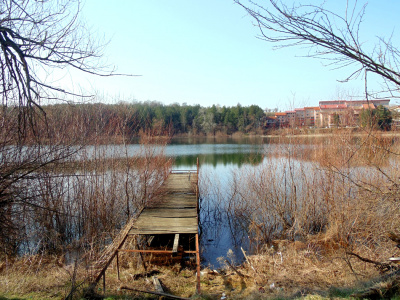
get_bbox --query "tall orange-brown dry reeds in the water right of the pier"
[227,133,400,258]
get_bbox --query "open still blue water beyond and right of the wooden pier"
[78,137,318,268]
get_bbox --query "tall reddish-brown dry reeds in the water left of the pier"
[0,102,171,255]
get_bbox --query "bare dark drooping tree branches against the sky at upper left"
[0,0,130,133]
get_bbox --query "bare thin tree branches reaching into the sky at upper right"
[235,0,400,97]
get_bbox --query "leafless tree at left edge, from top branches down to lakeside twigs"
[0,0,122,255]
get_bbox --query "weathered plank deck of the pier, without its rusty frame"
[129,172,198,234]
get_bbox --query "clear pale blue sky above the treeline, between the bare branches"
[67,0,400,110]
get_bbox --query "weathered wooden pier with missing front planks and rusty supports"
[90,168,200,293]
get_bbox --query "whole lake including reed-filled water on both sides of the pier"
[15,135,399,268]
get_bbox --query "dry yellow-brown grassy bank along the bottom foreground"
[0,241,400,299]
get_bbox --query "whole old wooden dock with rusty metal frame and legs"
[93,165,200,293]
